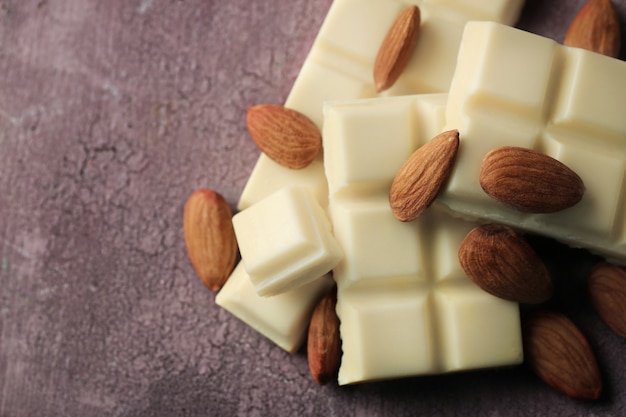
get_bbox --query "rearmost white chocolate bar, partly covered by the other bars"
[238,0,524,210]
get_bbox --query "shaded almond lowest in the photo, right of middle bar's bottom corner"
[523,311,602,400]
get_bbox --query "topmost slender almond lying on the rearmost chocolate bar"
[374,6,420,93]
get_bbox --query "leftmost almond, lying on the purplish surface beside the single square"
[183,189,238,291]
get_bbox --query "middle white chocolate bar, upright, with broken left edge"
[323,94,523,385]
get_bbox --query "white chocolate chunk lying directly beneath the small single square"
[215,262,333,353]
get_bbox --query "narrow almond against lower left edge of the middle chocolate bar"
[307,288,341,385]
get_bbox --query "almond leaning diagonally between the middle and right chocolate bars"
[389,130,459,222]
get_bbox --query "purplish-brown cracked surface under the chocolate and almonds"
[0,0,626,417]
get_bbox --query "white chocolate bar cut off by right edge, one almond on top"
[439,22,626,263]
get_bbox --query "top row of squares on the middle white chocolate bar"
[323,94,447,198]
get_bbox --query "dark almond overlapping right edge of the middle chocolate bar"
[459,224,554,304]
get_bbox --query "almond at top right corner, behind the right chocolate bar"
[563,0,622,58]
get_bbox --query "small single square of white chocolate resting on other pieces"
[233,187,342,296]
